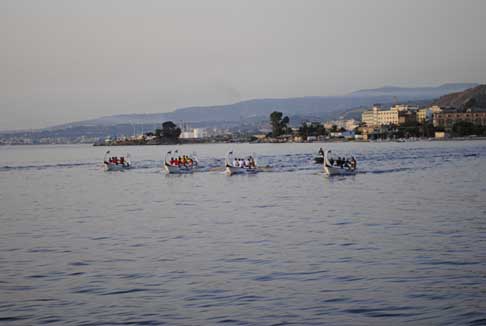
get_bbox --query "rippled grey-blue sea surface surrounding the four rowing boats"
[0,141,486,325]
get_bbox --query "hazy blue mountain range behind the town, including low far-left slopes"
[0,83,477,137]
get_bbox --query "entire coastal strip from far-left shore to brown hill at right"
[0,85,486,146]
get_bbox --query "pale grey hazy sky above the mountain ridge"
[0,0,486,129]
